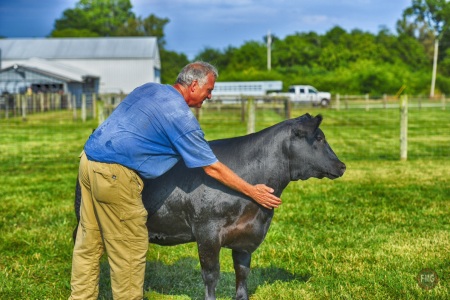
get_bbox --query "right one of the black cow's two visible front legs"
[232,250,252,300]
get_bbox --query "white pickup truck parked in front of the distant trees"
[277,85,331,107]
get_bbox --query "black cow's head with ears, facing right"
[289,114,345,180]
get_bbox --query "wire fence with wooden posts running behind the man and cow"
[0,94,450,160]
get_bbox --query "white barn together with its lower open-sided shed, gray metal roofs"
[0,37,161,95]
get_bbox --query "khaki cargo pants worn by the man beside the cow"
[70,152,148,300]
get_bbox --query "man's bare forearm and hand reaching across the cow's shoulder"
[203,162,281,209]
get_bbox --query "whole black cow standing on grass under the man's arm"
[75,114,345,299]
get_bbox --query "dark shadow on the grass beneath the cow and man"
[99,258,312,299]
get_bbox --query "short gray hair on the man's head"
[176,61,219,86]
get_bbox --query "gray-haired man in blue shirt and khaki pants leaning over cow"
[70,62,281,300]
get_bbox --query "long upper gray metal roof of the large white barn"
[0,37,158,60]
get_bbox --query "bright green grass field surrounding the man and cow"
[0,108,450,300]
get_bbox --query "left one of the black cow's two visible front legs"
[197,240,220,300]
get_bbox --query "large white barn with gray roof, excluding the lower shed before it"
[0,37,161,94]
